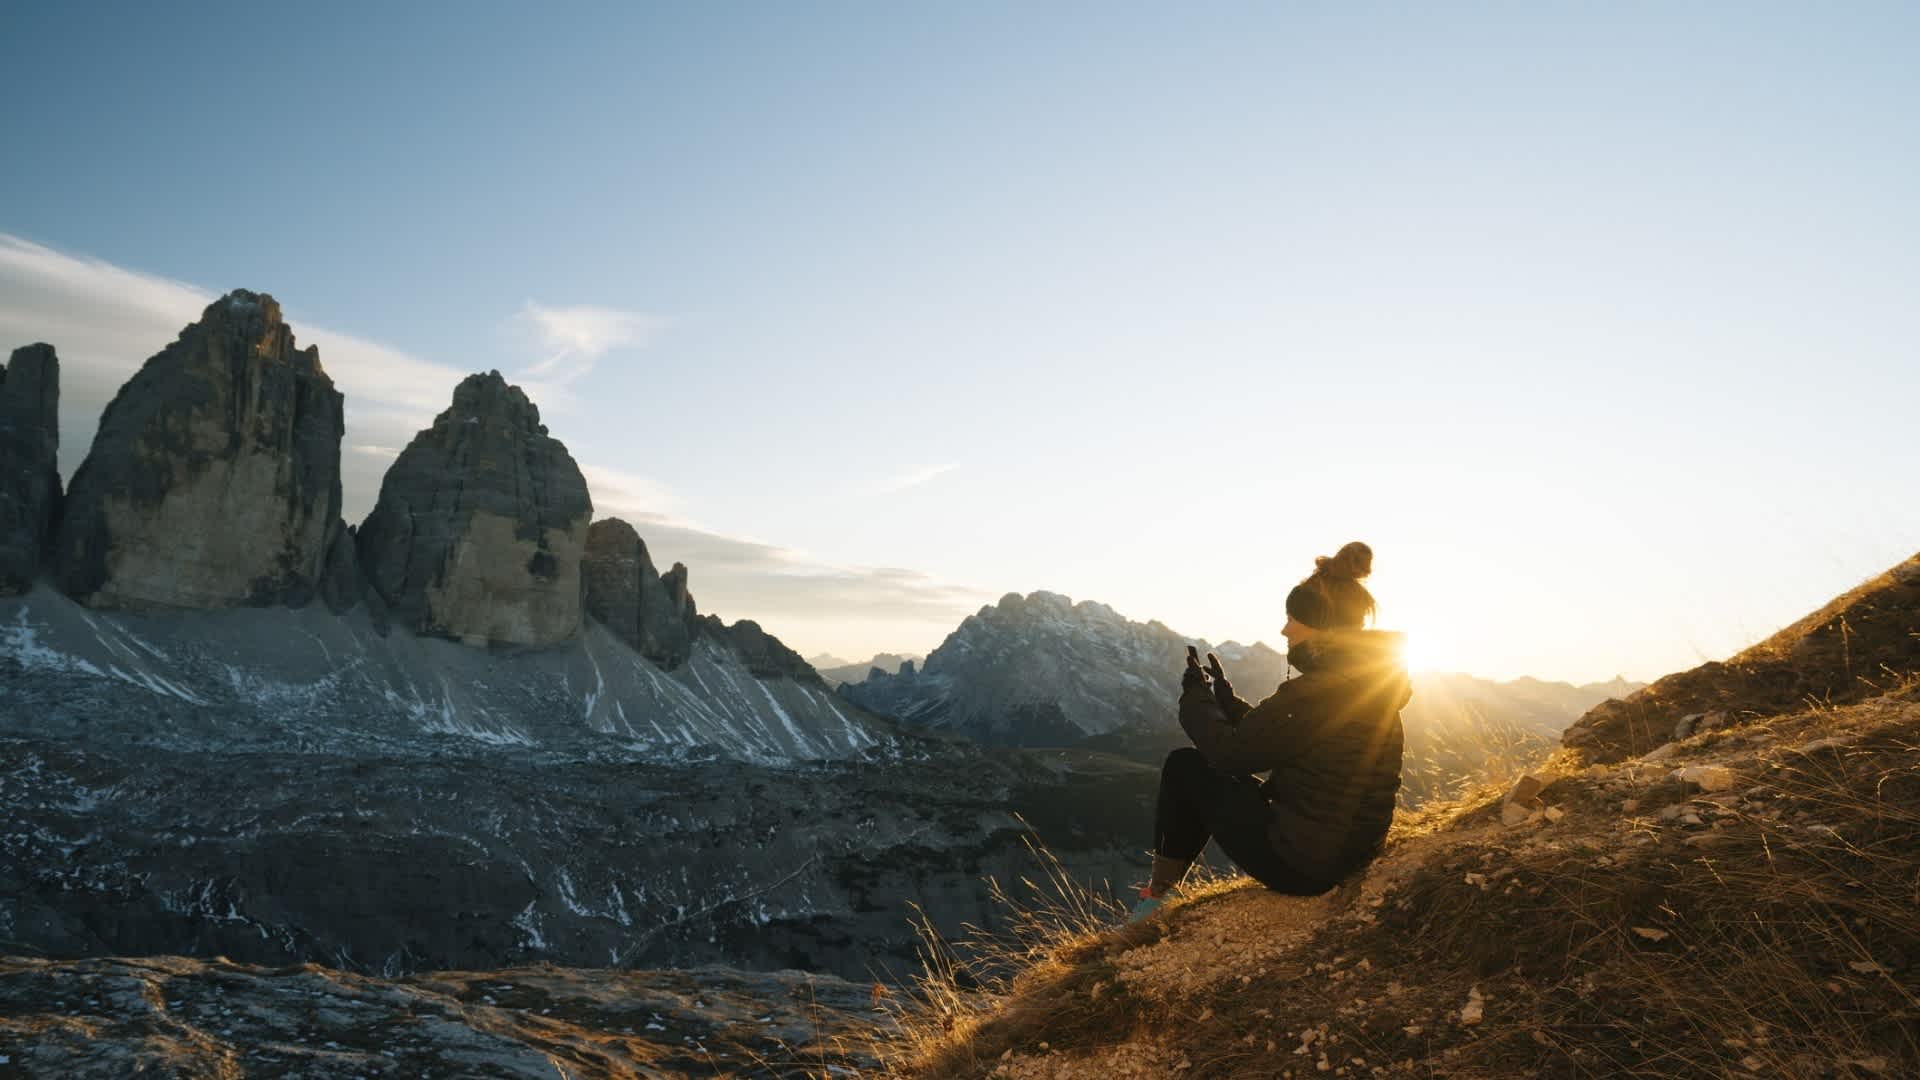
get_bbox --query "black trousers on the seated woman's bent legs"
[1154,746,1332,896]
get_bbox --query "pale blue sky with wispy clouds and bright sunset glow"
[0,2,1920,680]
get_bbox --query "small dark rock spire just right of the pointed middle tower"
[580,517,695,669]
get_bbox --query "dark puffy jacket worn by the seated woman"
[1181,630,1413,888]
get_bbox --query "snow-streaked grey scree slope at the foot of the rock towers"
[0,588,881,765]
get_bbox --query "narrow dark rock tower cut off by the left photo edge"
[0,344,60,596]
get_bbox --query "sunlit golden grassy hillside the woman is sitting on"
[879,559,1920,1080]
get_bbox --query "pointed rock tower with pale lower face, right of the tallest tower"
[355,371,593,648]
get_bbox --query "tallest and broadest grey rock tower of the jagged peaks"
[54,290,346,611]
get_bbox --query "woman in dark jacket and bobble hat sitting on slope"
[1133,542,1411,919]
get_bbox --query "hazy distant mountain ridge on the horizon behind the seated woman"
[839,592,1638,799]
